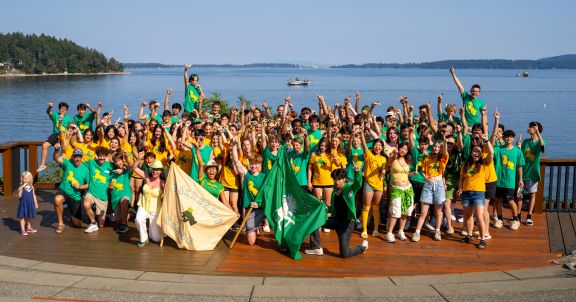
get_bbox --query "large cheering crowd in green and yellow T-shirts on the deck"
[18,65,545,257]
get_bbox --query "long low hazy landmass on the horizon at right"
[330,54,576,69]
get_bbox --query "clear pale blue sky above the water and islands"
[0,0,576,64]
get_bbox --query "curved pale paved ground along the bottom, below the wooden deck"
[0,256,576,302]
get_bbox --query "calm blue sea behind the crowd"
[0,68,576,157]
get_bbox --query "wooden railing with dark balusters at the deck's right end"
[535,158,576,212]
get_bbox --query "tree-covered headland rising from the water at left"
[0,33,124,75]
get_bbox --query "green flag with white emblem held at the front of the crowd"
[256,150,328,259]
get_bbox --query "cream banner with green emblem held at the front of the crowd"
[157,163,239,251]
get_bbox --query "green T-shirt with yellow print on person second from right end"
[494,146,524,189]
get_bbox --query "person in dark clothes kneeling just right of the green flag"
[304,165,368,258]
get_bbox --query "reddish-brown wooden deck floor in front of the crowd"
[0,190,556,277]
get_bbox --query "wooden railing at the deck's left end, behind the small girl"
[0,142,54,197]
